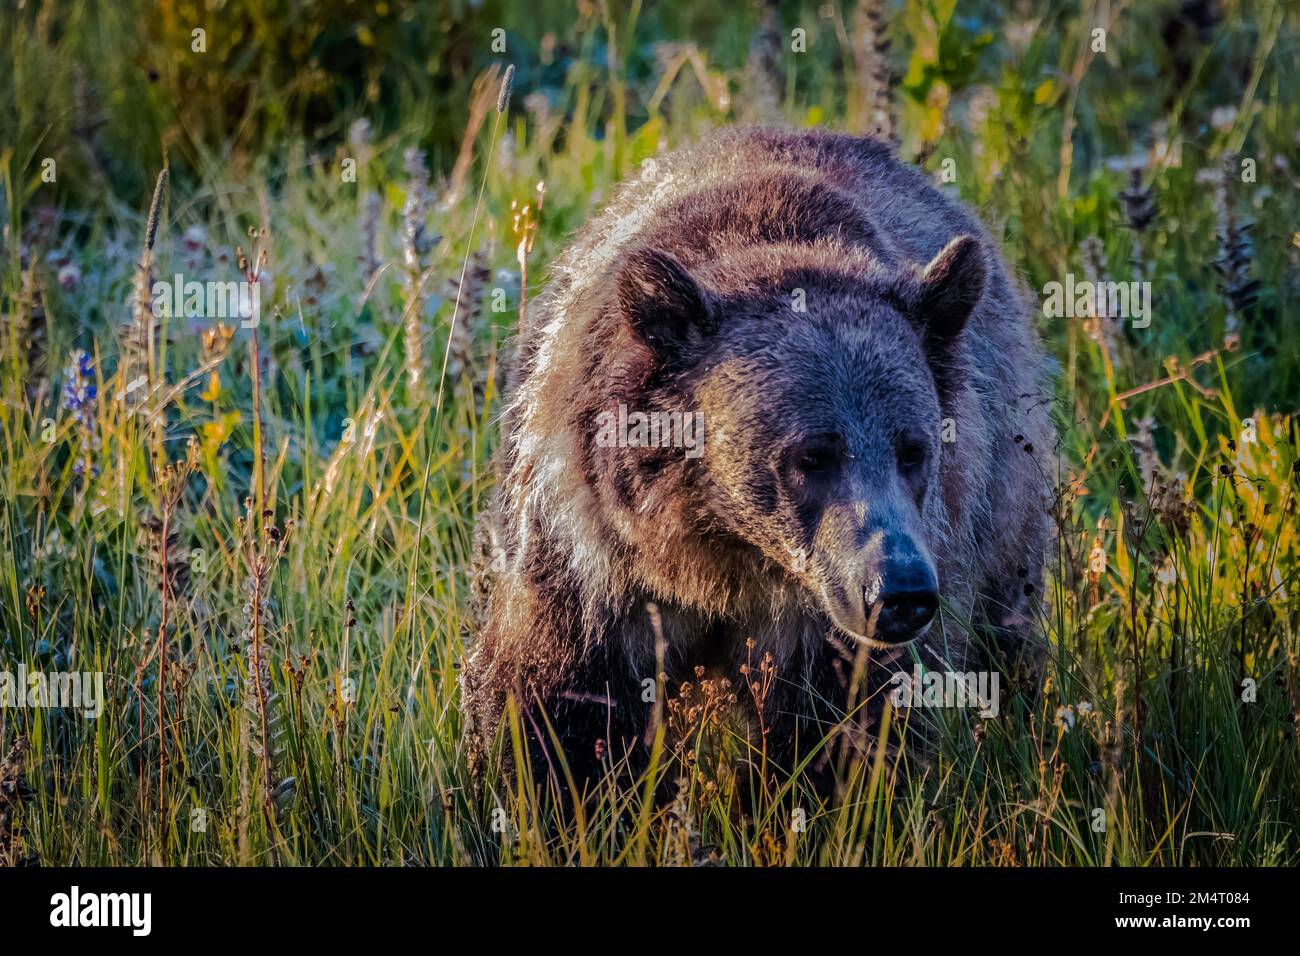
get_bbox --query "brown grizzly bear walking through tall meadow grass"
[462,129,1054,783]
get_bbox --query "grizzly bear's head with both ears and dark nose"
[612,235,985,644]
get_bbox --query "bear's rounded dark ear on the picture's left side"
[618,248,715,358]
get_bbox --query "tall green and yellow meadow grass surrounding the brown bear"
[0,0,1300,865]
